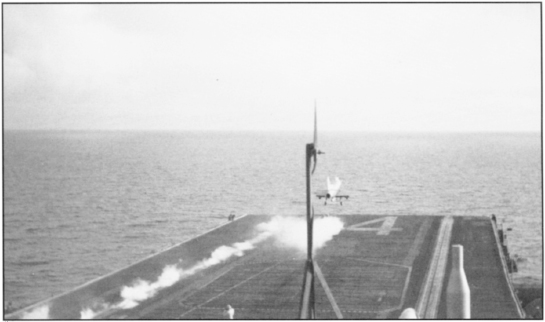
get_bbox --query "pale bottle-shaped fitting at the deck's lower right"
[447,245,471,319]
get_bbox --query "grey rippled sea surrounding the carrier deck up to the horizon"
[4,131,543,306]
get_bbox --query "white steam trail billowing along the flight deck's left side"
[80,216,343,319]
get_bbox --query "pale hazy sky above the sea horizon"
[3,3,541,131]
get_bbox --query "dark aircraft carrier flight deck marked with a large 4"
[4,215,524,320]
